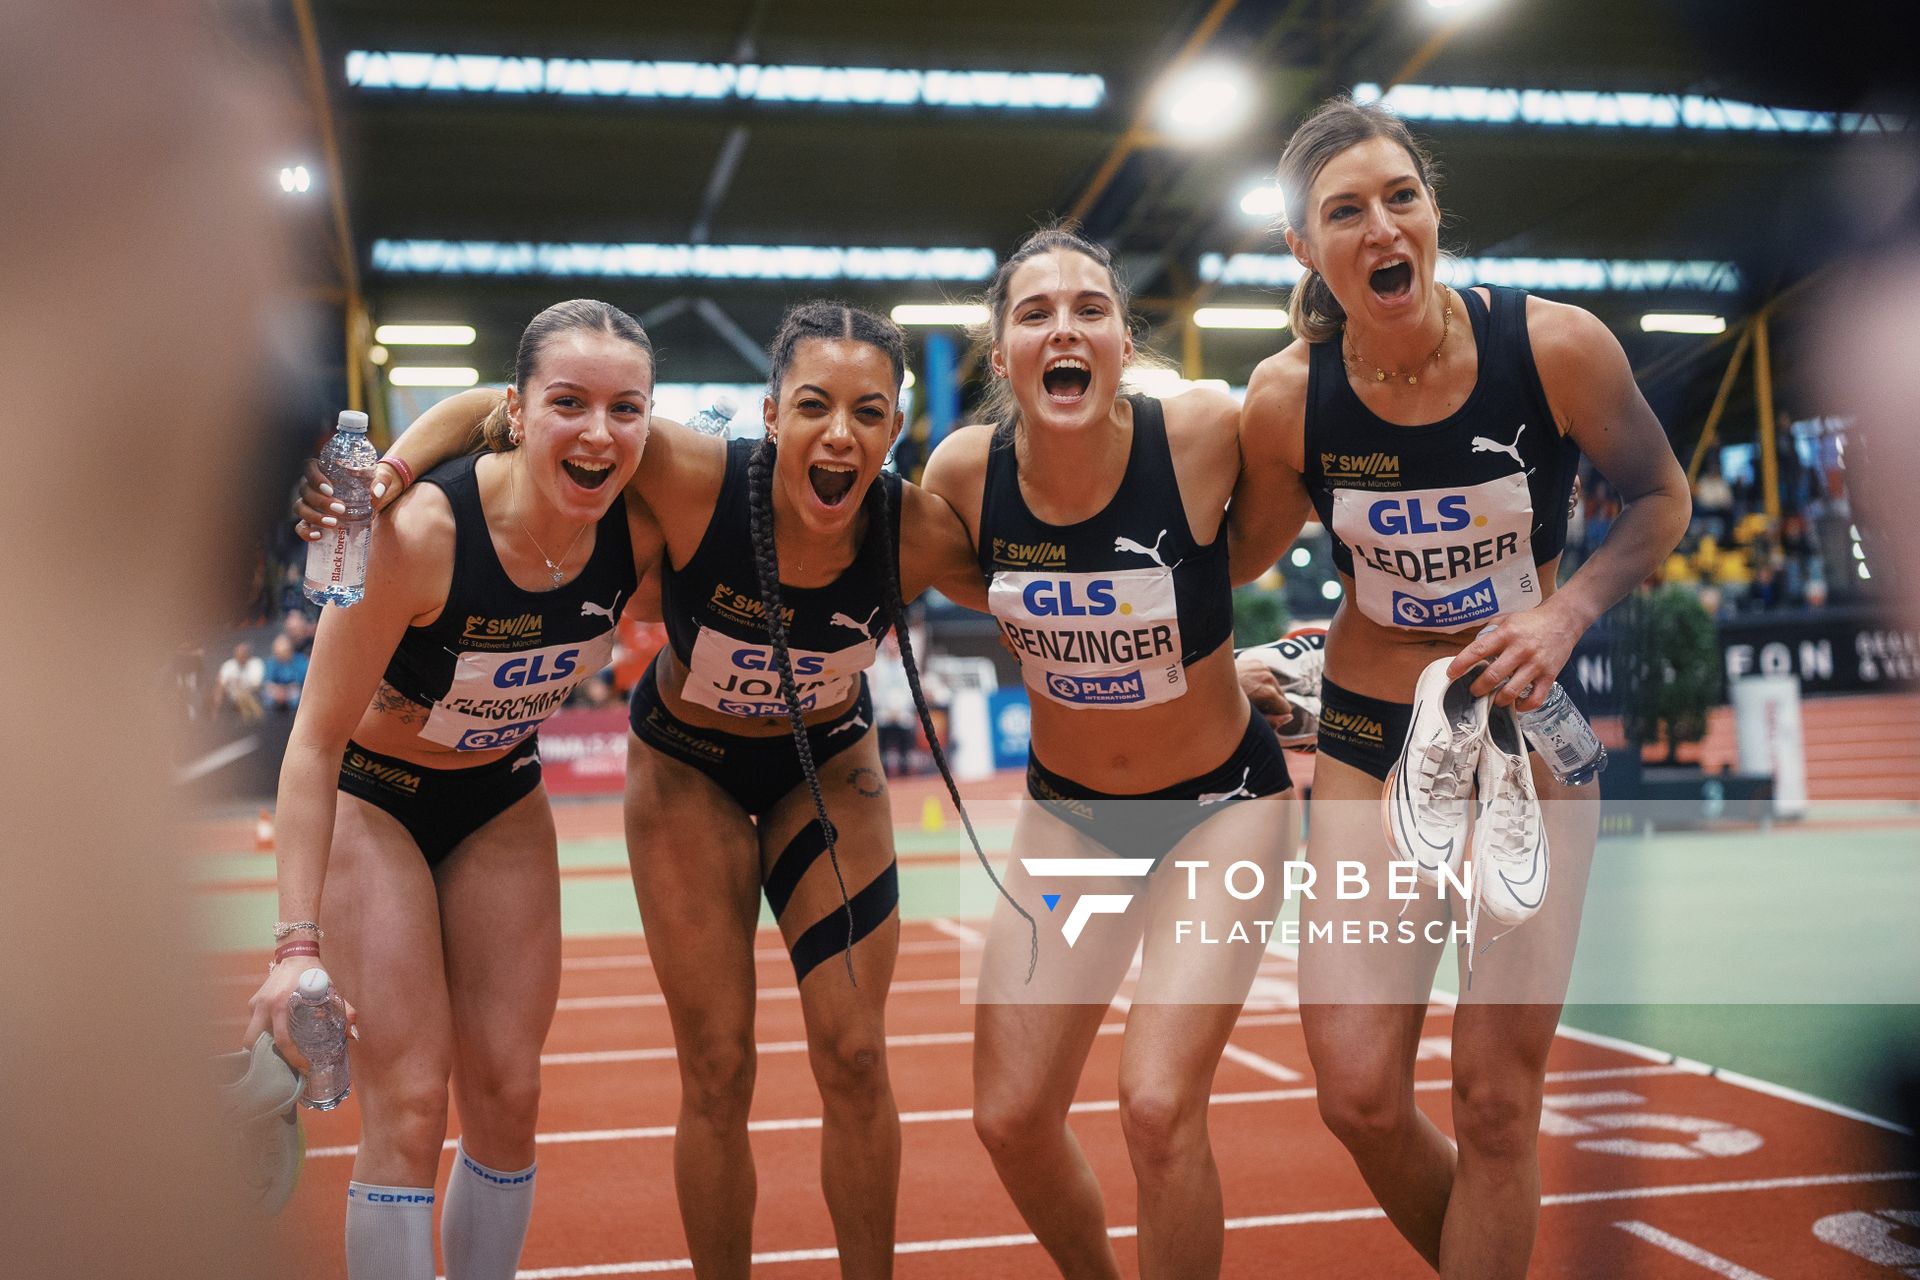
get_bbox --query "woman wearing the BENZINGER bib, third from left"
[925,228,1298,1278]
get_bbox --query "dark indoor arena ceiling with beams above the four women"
[282,0,1910,433]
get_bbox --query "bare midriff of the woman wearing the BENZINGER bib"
[1031,643,1252,794]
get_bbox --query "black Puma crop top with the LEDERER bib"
[1304,286,1580,631]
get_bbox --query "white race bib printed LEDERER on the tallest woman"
[1332,472,1544,631]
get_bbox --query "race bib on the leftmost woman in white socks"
[420,631,612,750]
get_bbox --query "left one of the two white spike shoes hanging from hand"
[1380,656,1488,885]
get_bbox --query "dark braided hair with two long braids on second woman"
[747,301,1041,986]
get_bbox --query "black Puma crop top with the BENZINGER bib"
[979,395,1233,708]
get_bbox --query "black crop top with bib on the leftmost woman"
[386,455,636,750]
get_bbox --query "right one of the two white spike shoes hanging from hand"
[1471,706,1548,927]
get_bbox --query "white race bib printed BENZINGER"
[987,566,1187,708]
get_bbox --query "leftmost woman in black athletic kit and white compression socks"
[248,301,659,1280]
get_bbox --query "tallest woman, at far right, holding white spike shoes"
[1233,100,1690,1280]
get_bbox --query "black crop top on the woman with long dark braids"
[660,439,900,716]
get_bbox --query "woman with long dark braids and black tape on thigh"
[326,303,1031,1276]
